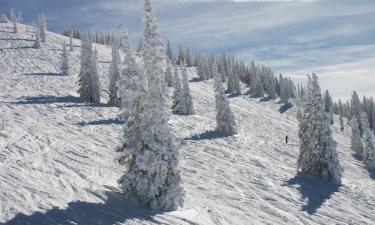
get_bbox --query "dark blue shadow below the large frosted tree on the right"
[286,173,340,215]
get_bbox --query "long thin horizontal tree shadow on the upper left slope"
[16,95,84,105]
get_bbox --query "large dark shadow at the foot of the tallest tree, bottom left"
[0,192,158,225]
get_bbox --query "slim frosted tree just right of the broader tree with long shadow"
[108,45,121,106]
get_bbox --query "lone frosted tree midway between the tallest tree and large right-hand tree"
[213,63,237,135]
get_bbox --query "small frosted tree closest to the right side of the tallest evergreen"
[172,65,194,115]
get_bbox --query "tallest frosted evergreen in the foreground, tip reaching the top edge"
[119,0,183,211]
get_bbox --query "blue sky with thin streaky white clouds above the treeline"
[0,0,375,97]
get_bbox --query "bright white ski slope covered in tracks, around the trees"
[0,24,375,225]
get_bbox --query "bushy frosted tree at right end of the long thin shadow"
[78,37,100,104]
